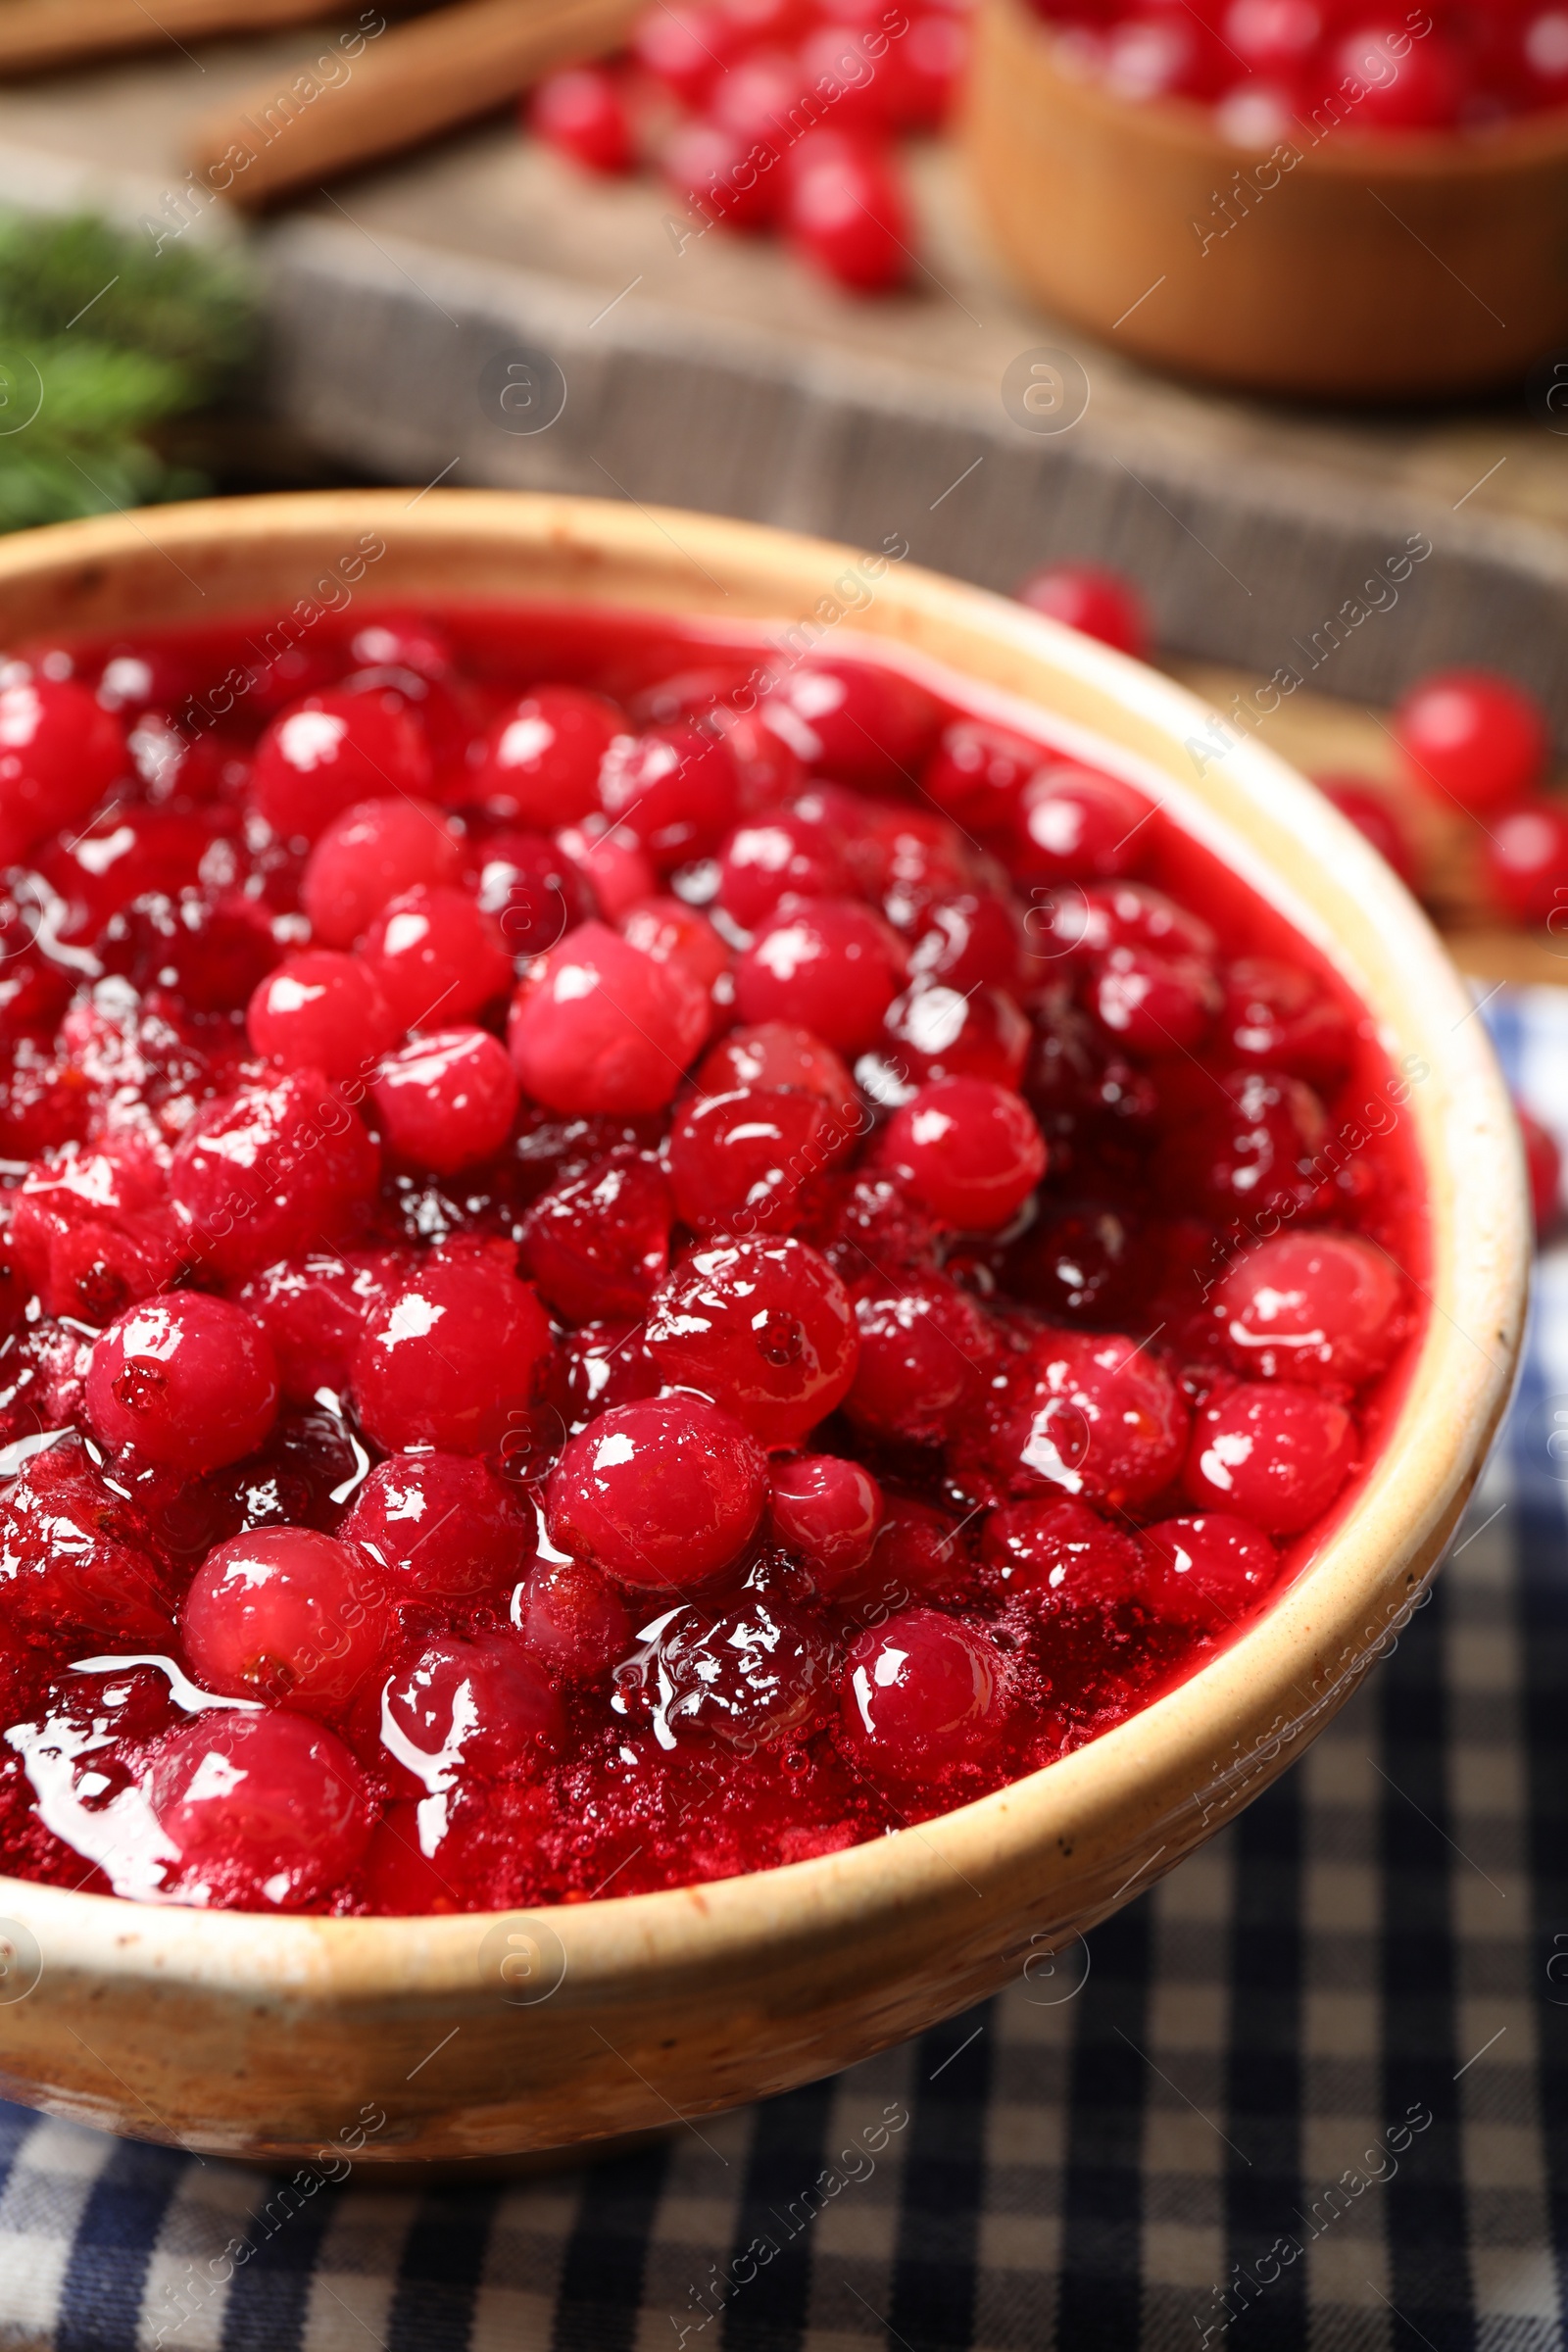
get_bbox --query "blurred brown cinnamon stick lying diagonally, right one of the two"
[188,0,637,210]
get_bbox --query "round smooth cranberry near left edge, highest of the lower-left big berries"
[87,1292,277,1472]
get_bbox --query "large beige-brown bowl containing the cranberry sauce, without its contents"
[0,492,1528,2162]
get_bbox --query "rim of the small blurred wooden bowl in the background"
[980,0,1568,181]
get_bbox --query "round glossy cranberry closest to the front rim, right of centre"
[844,1609,1006,1783]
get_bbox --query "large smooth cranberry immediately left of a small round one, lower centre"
[550,1397,766,1592]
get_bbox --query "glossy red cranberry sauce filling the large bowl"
[0,610,1425,1912]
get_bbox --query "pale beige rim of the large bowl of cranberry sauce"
[0,489,1531,2006]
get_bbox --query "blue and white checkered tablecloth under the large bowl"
[0,993,1568,2352]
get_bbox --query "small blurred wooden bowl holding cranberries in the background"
[961,0,1568,400]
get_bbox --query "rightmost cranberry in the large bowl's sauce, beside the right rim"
[1213,1233,1405,1388]
